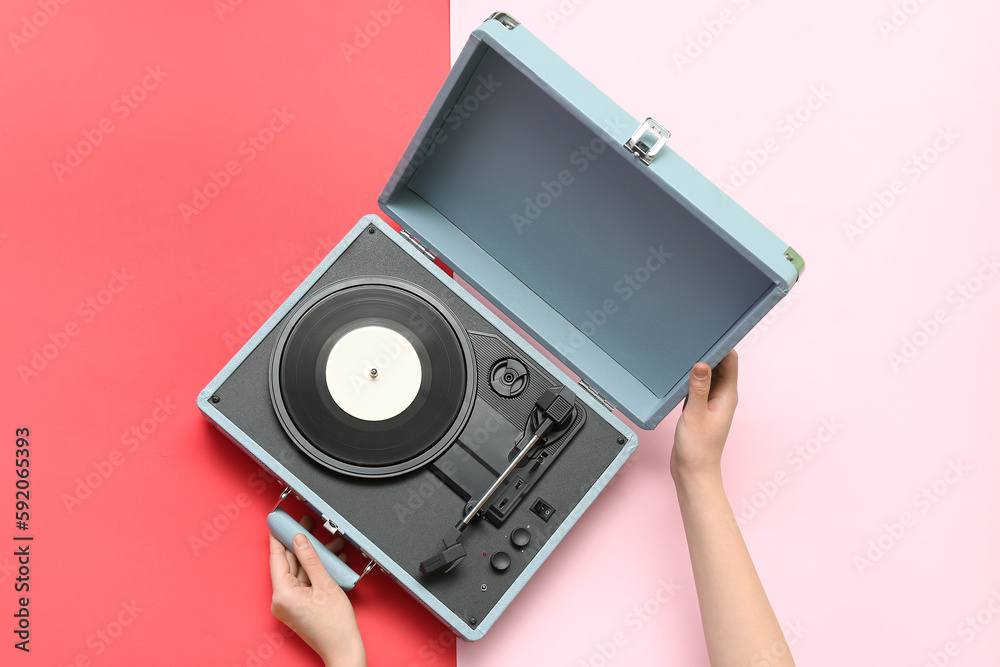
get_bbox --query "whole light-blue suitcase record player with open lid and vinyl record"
[198,13,803,640]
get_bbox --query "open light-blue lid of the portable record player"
[379,14,803,429]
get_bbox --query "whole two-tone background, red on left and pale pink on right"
[0,0,1000,667]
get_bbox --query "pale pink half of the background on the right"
[451,0,1000,667]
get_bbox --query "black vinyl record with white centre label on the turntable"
[270,276,476,477]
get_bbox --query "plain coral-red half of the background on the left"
[0,0,455,665]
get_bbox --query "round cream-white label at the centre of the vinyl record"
[326,326,423,421]
